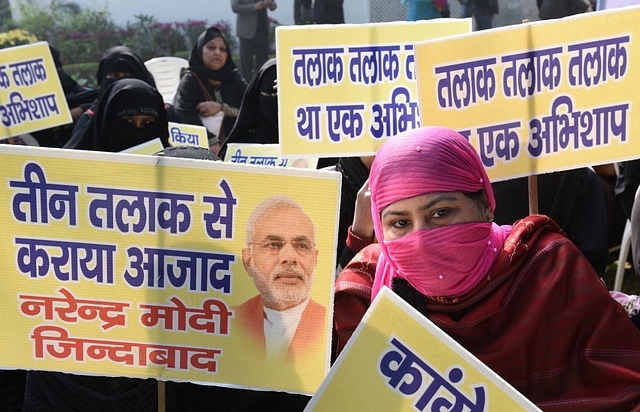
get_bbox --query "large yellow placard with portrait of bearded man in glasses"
[0,145,340,394]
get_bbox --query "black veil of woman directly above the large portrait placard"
[93,78,169,152]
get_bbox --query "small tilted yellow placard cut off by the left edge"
[0,42,72,139]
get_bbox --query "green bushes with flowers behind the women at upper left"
[0,0,237,86]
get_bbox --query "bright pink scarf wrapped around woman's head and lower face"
[369,127,510,300]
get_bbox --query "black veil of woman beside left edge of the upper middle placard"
[224,59,279,149]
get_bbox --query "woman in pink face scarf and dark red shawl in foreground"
[334,127,640,411]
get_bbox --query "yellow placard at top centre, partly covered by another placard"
[276,19,471,157]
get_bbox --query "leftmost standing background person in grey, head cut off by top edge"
[231,0,278,82]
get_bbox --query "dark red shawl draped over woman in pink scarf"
[334,215,640,412]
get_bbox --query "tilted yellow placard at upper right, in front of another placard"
[416,6,640,181]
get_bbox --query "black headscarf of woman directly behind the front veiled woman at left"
[96,46,156,91]
